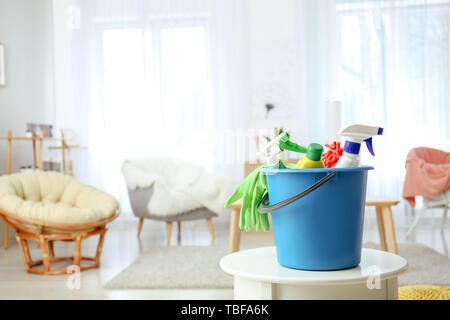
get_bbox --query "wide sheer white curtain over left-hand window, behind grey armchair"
[62,0,246,215]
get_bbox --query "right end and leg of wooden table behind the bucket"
[366,197,400,254]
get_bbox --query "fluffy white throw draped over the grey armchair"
[122,157,231,216]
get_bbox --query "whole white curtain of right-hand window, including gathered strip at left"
[296,0,450,220]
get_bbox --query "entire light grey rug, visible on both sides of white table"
[105,242,450,289]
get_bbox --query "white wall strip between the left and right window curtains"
[246,0,297,138]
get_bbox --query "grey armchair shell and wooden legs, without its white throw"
[128,186,217,245]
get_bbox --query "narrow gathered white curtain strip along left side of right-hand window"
[294,0,339,144]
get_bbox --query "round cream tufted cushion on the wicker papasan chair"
[0,171,119,224]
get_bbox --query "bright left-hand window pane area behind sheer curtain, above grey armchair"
[102,22,212,168]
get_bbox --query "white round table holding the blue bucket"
[220,247,408,300]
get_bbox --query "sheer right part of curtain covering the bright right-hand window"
[337,0,450,218]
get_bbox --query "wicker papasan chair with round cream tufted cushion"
[0,172,119,275]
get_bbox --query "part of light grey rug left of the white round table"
[105,246,233,289]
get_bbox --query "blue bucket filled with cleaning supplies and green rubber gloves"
[225,125,383,270]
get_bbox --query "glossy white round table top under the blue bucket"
[220,247,408,285]
